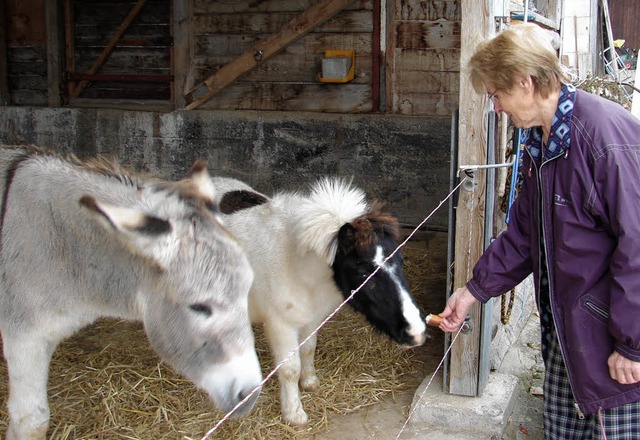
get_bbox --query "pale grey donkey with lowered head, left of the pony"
[0,148,262,440]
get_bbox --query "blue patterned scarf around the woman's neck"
[521,84,576,165]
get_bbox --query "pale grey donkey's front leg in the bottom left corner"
[3,334,56,440]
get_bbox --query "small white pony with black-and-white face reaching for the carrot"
[213,177,426,425]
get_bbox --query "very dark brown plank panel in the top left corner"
[0,0,48,105]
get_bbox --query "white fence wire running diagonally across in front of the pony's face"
[190,176,469,440]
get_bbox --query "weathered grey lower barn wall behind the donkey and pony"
[0,107,451,230]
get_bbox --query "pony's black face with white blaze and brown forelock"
[333,215,426,347]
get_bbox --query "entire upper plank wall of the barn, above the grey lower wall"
[4,0,461,116]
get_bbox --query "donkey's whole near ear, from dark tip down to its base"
[79,195,172,270]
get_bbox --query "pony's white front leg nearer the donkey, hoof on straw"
[264,317,309,426]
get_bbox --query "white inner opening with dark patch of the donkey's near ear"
[79,195,171,237]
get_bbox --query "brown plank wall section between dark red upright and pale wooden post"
[387,0,461,115]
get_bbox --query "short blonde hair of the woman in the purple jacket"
[467,23,568,98]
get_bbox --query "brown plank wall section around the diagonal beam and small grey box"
[192,0,373,113]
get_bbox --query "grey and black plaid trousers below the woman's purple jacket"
[544,329,640,440]
